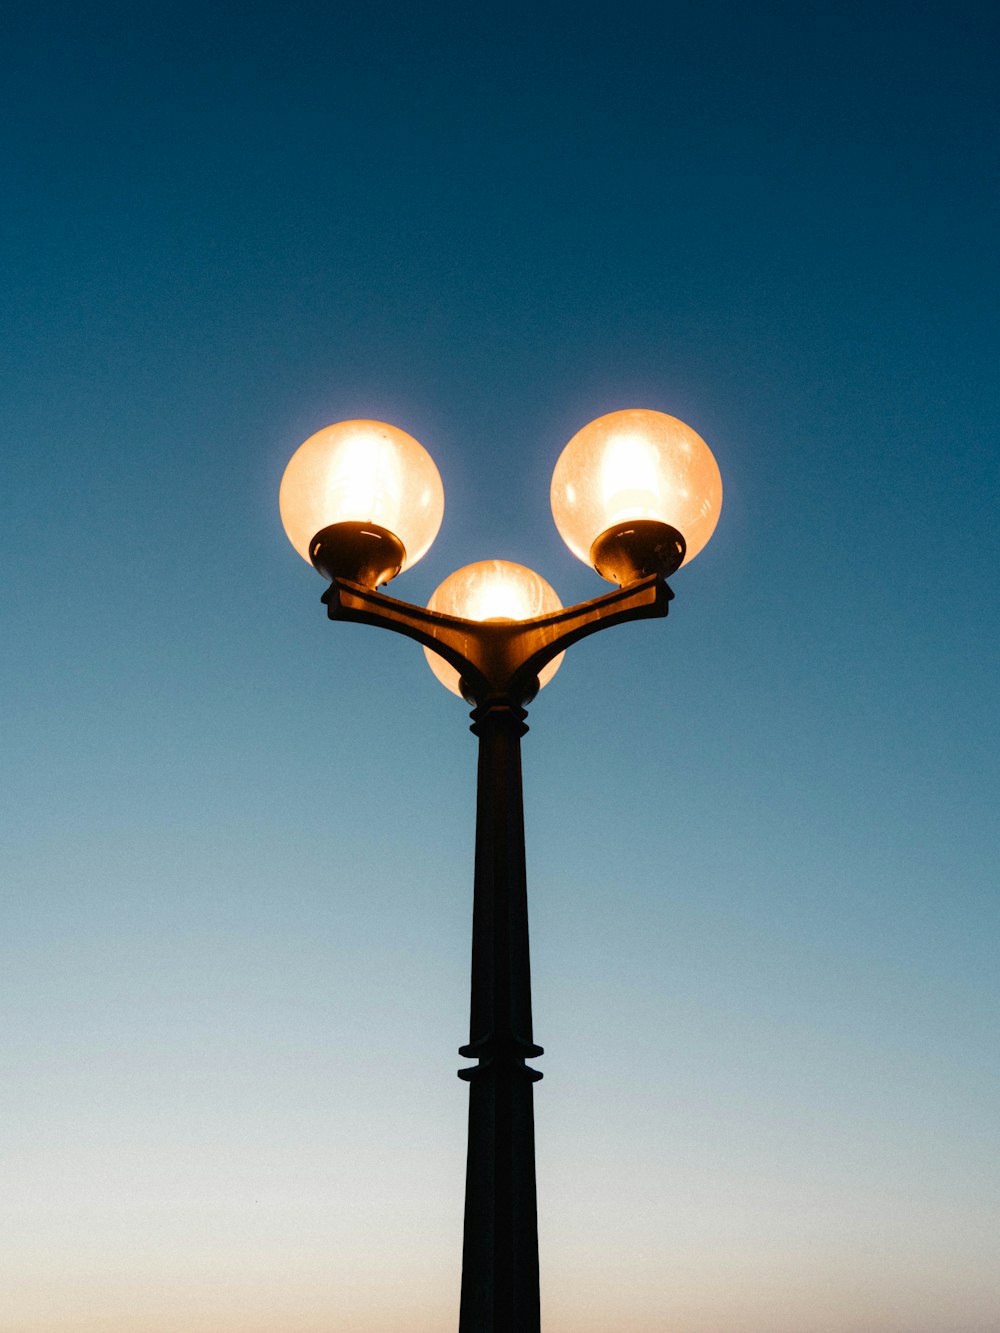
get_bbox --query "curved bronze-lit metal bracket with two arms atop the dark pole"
[323,575,673,706]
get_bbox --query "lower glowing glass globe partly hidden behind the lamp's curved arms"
[424,560,565,697]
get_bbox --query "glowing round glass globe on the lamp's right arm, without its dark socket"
[552,408,723,572]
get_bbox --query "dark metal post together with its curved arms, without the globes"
[313,570,673,1333]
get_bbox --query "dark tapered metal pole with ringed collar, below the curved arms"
[459,704,541,1333]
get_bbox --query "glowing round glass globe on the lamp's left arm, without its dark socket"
[279,421,444,577]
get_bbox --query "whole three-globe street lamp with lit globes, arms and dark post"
[280,409,723,1333]
